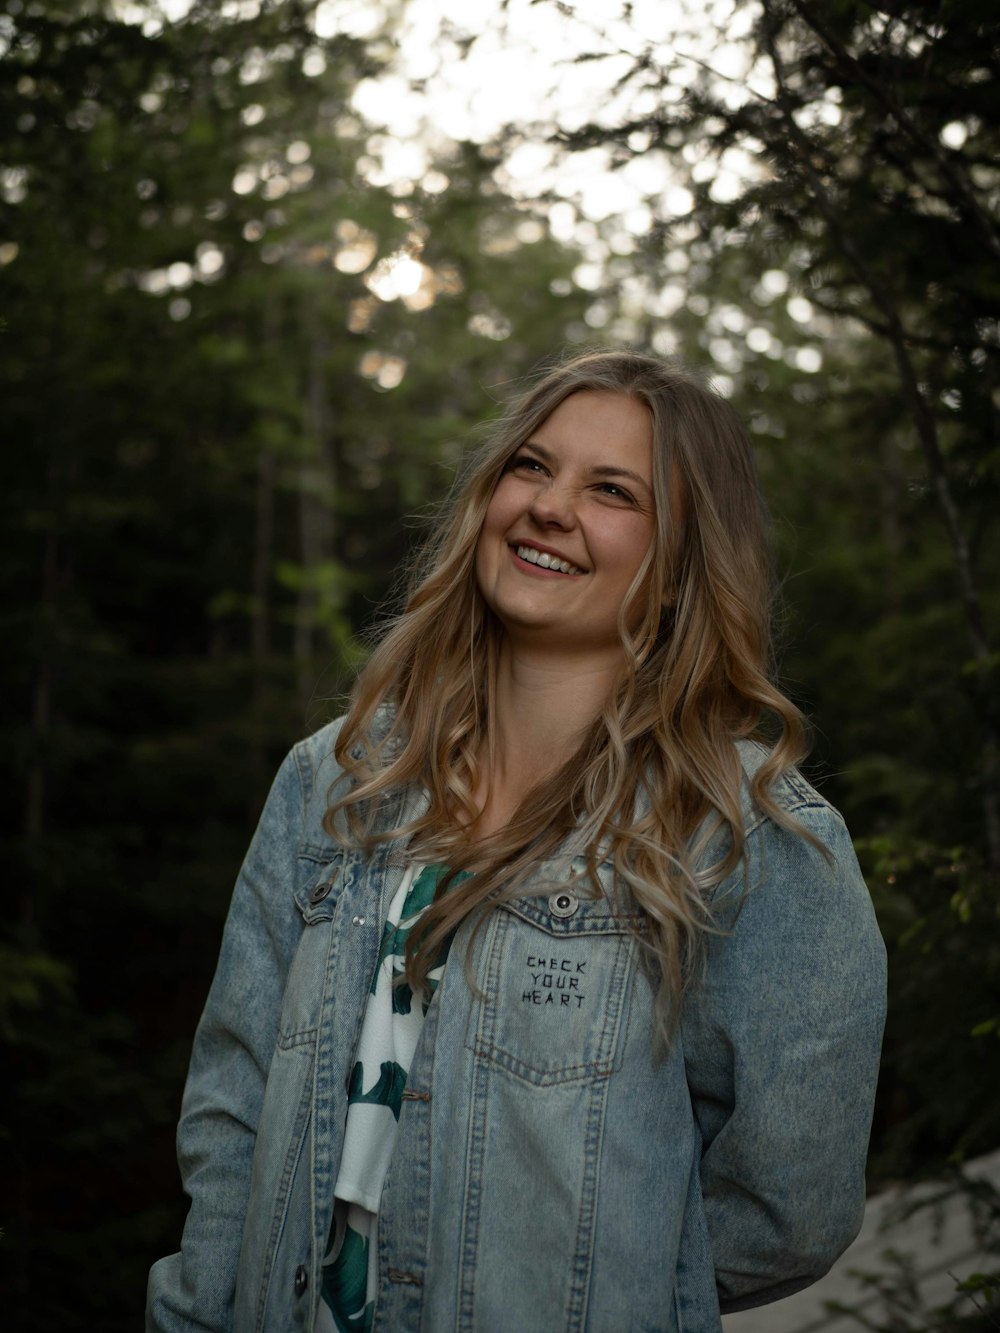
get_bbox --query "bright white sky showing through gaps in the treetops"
[98,0,840,370]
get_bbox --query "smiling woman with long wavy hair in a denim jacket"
[148,352,884,1333]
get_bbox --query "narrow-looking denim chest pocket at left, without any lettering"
[277,848,348,1049]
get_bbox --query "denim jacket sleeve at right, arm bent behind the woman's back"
[681,805,885,1313]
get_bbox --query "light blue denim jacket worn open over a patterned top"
[147,724,885,1333]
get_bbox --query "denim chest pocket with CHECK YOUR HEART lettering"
[467,886,639,1088]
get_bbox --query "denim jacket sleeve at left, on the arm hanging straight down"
[145,745,312,1333]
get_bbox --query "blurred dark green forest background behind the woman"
[0,0,1000,1333]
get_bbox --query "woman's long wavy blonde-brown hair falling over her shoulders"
[325,352,805,1036]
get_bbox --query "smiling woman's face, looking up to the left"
[476,389,655,656]
